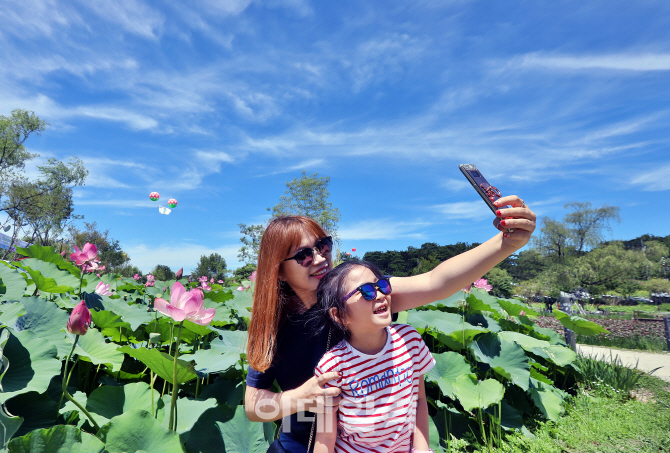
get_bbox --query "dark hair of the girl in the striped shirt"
[313,261,383,340]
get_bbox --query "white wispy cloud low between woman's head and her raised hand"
[338,218,431,241]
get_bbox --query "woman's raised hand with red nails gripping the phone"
[493,195,536,250]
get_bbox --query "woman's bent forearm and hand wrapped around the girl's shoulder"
[244,372,341,422]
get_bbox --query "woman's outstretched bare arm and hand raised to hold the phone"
[391,195,535,312]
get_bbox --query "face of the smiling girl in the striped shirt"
[344,266,391,338]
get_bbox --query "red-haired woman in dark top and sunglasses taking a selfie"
[245,196,535,453]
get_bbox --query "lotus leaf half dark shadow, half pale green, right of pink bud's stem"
[85,382,164,426]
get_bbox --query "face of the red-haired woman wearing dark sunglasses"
[279,233,333,307]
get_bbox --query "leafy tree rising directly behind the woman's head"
[272,170,340,242]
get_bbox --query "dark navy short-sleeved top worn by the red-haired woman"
[247,305,398,451]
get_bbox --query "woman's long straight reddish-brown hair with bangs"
[247,216,328,372]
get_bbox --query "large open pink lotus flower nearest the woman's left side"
[154,282,216,326]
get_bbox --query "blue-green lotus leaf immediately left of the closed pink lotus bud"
[10,297,72,358]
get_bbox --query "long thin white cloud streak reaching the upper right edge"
[515,52,670,71]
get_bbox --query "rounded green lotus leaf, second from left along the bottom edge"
[98,409,184,453]
